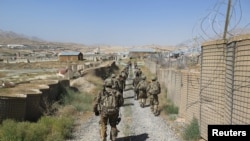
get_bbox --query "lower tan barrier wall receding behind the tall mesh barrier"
[157,69,200,122]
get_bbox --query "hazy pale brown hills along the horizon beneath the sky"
[0,29,176,53]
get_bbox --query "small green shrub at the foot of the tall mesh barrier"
[182,118,200,141]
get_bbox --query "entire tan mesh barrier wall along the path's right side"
[145,34,250,140]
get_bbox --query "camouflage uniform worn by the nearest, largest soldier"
[94,80,124,141]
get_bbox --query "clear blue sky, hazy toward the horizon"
[0,0,250,46]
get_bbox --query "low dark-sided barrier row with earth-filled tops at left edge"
[0,80,69,122]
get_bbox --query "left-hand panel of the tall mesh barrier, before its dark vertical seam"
[200,40,226,139]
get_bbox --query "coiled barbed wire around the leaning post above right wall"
[192,0,250,42]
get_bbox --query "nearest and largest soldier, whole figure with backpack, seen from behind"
[93,79,124,141]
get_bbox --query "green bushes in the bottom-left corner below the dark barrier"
[0,116,74,141]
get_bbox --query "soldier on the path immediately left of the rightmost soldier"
[136,75,148,108]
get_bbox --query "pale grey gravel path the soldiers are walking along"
[67,67,182,141]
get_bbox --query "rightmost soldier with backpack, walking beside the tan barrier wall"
[147,76,161,116]
